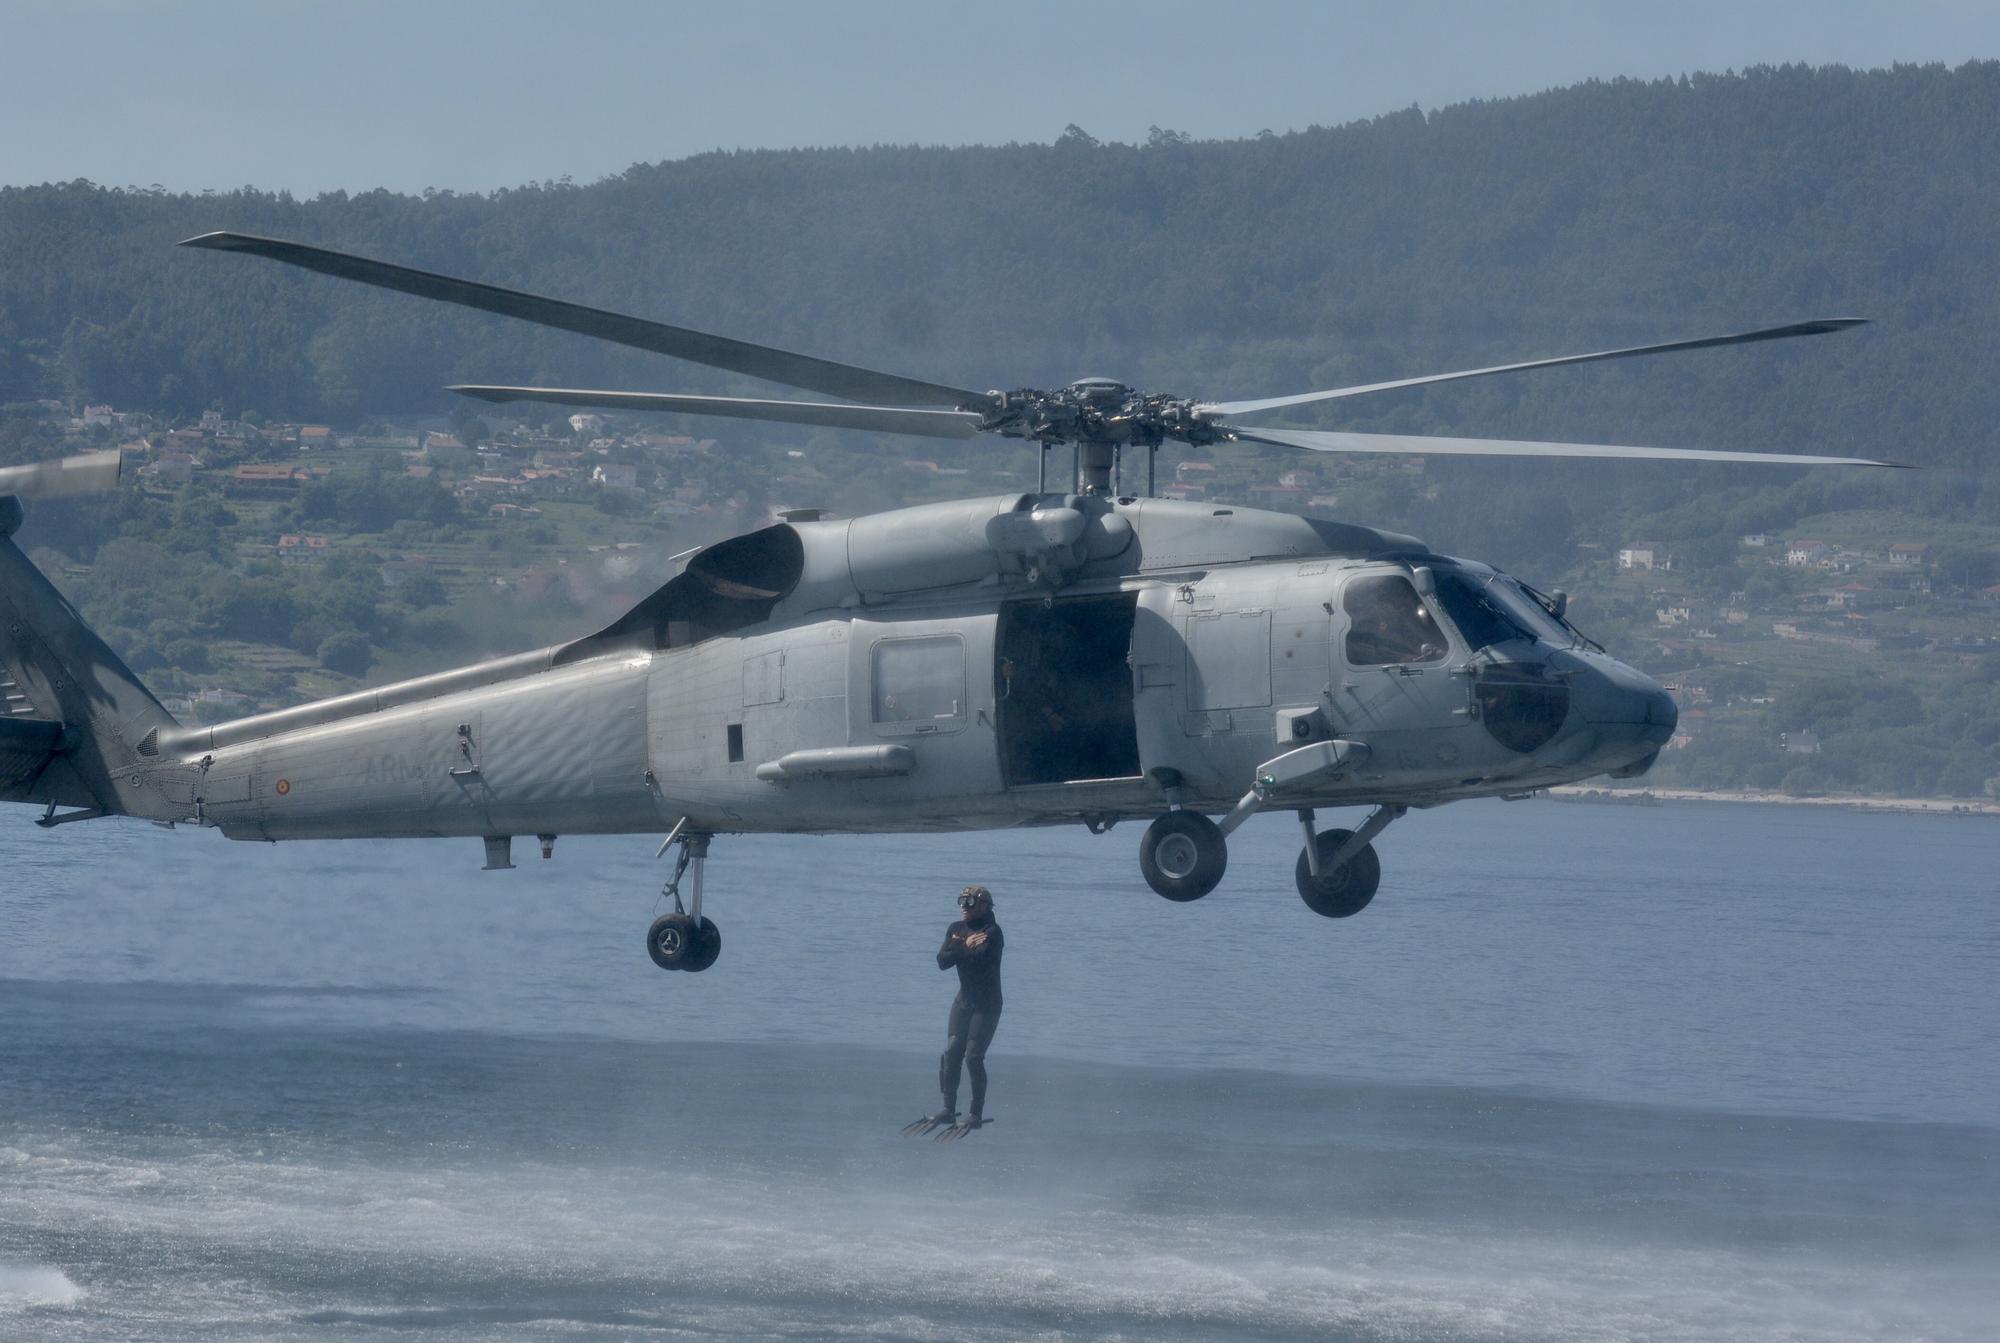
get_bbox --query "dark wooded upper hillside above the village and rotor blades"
[0,64,2000,439]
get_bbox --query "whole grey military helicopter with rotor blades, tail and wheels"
[0,232,1894,969]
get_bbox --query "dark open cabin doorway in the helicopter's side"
[994,592,1138,787]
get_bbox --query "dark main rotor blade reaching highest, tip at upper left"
[180,232,992,410]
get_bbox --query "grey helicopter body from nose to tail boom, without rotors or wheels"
[120,496,1674,839]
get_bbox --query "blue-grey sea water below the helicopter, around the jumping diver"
[0,801,2000,1341]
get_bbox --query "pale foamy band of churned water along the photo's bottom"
[0,1135,1992,1343]
